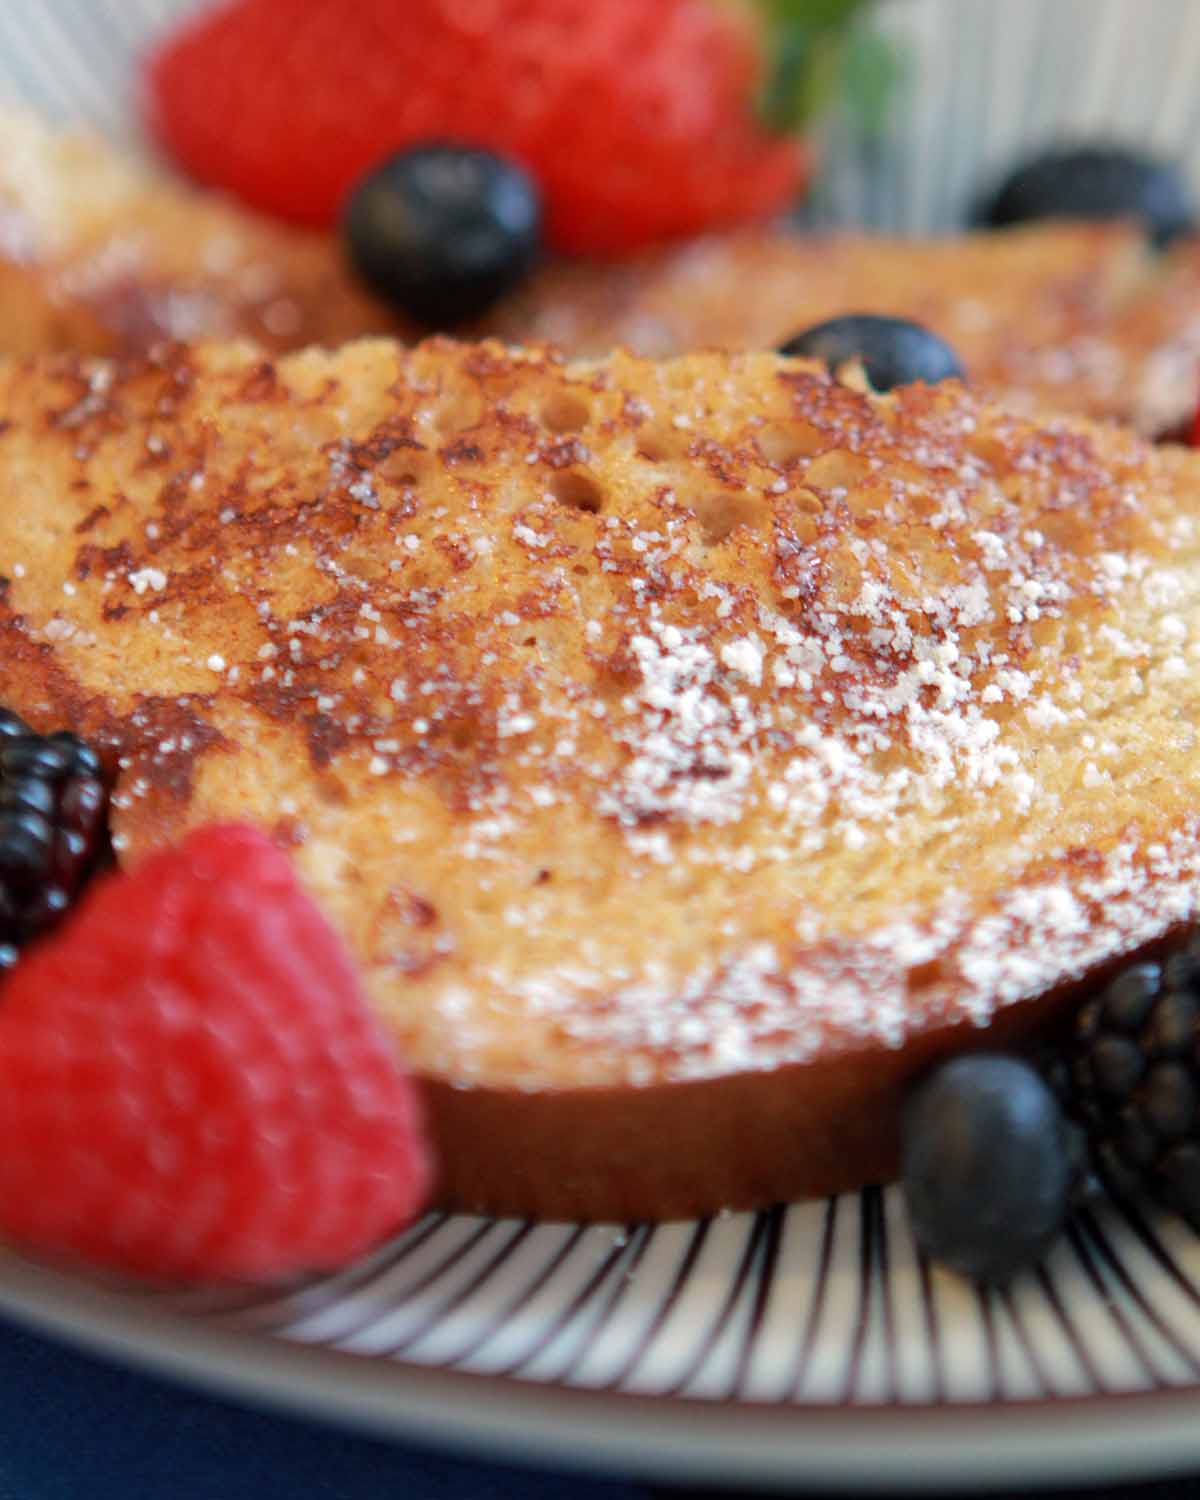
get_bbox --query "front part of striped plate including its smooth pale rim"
[9,1190,1200,1490]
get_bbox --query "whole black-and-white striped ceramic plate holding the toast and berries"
[0,0,1200,1490]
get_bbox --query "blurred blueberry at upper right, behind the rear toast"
[975,146,1193,246]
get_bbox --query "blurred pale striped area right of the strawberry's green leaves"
[804,0,1200,234]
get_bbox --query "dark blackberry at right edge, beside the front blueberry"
[1058,930,1200,1230]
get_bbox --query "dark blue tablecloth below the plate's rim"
[0,1320,1200,1500]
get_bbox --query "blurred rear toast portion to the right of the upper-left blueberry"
[488,222,1170,432]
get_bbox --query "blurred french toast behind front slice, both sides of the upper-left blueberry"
[0,113,1200,432]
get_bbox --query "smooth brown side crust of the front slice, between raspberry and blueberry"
[422,978,1116,1221]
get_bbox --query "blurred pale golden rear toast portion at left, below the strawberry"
[0,110,405,354]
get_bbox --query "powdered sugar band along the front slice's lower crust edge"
[530,819,1200,1082]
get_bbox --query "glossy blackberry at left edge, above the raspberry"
[0,708,111,971]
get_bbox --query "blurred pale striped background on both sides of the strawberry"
[0,0,1200,234]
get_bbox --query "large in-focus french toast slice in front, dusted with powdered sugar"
[0,341,1200,1218]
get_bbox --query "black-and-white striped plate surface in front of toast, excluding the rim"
[119,1188,1200,1407]
